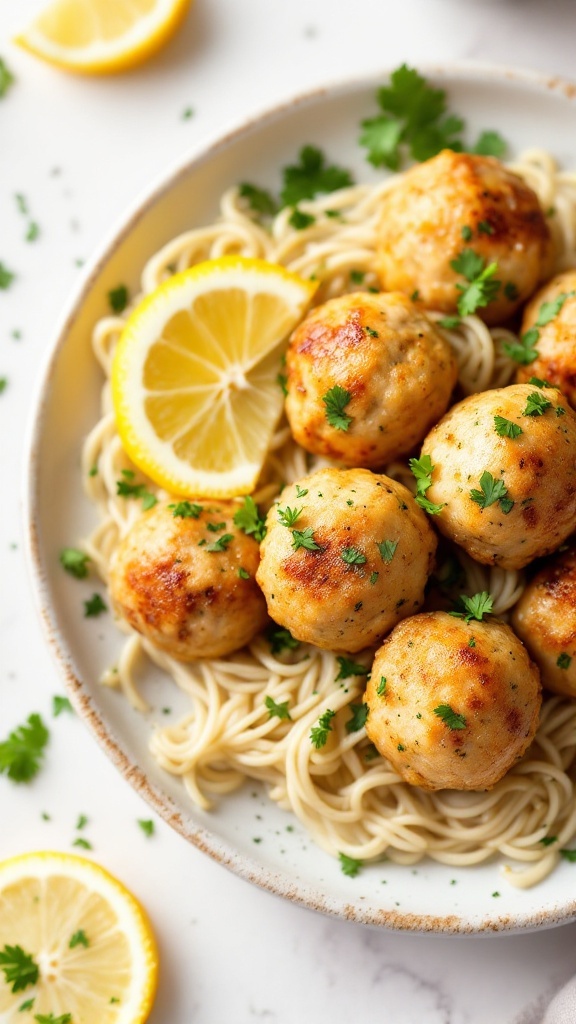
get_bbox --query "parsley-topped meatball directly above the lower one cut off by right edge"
[422,384,576,569]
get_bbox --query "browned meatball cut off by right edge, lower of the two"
[512,543,576,697]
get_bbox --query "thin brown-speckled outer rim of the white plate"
[23,61,576,935]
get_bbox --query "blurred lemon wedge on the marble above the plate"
[14,0,191,75]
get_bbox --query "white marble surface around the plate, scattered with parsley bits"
[0,0,576,1024]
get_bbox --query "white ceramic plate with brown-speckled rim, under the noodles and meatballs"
[27,68,576,932]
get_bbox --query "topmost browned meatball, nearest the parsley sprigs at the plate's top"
[377,150,551,324]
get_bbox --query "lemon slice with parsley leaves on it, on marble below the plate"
[0,853,158,1024]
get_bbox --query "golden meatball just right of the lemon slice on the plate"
[286,292,457,467]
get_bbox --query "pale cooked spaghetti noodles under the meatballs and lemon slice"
[83,150,576,887]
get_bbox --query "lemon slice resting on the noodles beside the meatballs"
[112,256,317,498]
